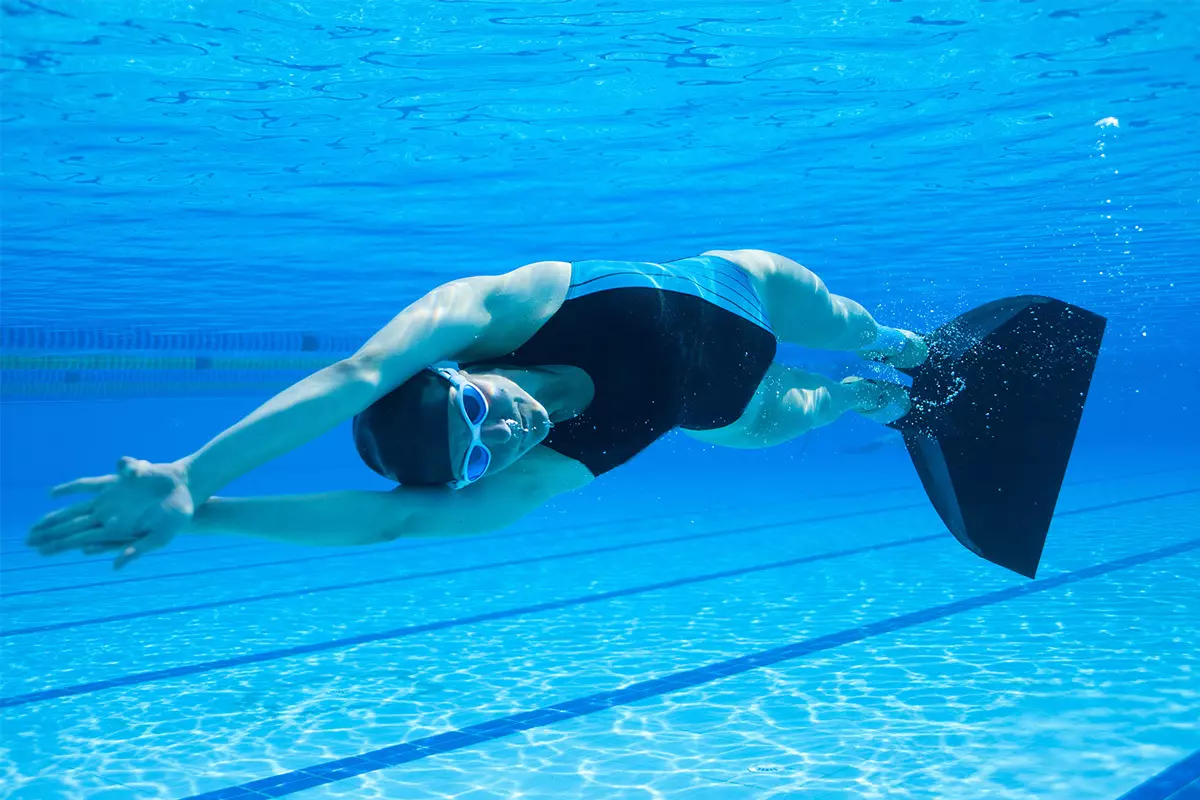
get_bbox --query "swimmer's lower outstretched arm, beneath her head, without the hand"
[187,447,592,547]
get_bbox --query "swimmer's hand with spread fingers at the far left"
[26,456,196,570]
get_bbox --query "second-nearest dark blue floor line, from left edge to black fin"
[0,534,944,708]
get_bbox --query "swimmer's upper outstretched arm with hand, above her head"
[26,261,570,569]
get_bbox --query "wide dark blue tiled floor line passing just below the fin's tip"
[185,539,1200,800]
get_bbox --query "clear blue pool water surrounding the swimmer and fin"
[0,0,1200,800]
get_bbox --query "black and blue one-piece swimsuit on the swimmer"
[463,255,776,475]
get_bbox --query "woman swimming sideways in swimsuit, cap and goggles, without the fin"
[28,249,929,569]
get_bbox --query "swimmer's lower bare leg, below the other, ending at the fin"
[685,363,910,449]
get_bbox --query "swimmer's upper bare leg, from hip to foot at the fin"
[704,249,929,368]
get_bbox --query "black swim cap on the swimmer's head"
[354,369,456,486]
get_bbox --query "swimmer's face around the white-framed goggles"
[448,373,550,477]
